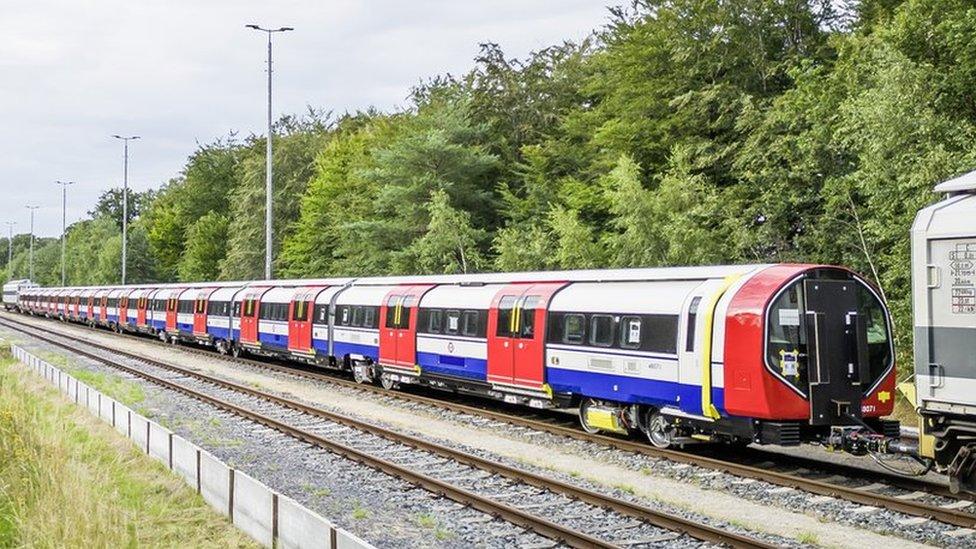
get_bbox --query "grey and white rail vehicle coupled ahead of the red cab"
[902,168,976,493]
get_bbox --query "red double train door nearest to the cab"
[488,282,566,389]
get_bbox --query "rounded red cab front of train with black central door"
[726,265,899,454]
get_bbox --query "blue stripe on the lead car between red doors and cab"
[546,366,725,414]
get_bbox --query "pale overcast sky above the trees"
[0,0,619,236]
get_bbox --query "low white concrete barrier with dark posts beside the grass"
[3,345,372,549]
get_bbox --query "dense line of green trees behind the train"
[0,0,976,376]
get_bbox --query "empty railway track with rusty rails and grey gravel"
[0,319,773,548]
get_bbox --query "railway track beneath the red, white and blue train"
[4,316,976,528]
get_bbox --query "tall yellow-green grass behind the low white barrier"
[0,351,256,547]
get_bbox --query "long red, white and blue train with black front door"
[8,264,898,447]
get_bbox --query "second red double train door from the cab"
[380,285,433,368]
